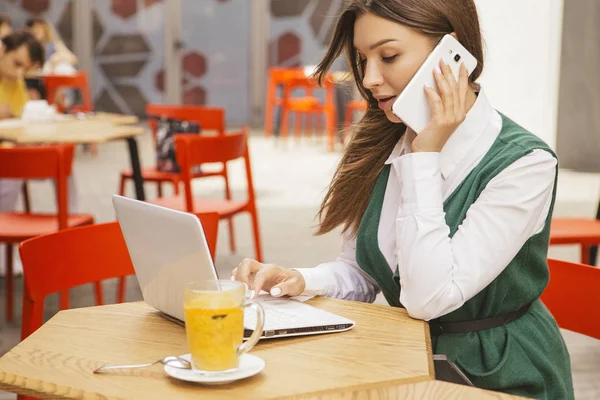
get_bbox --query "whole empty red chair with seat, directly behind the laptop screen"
[151,127,262,261]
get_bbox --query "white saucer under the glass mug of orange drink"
[165,353,265,385]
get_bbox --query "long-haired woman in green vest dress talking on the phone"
[232,0,574,399]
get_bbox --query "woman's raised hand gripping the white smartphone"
[411,60,469,152]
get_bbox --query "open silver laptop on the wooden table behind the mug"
[113,195,355,338]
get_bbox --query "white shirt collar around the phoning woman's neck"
[385,89,496,179]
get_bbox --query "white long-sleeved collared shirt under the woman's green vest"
[297,90,556,321]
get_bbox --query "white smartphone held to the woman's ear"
[392,35,477,134]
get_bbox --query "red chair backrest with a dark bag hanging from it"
[146,104,225,143]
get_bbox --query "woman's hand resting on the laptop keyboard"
[231,258,306,298]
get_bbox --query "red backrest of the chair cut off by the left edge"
[0,145,75,229]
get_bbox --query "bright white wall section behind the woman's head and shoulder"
[475,0,564,149]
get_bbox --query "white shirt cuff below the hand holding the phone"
[392,153,444,217]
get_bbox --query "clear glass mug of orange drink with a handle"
[183,280,265,372]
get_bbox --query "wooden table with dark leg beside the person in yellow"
[0,113,146,200]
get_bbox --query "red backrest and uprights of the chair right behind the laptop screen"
[175,127,254,212]
